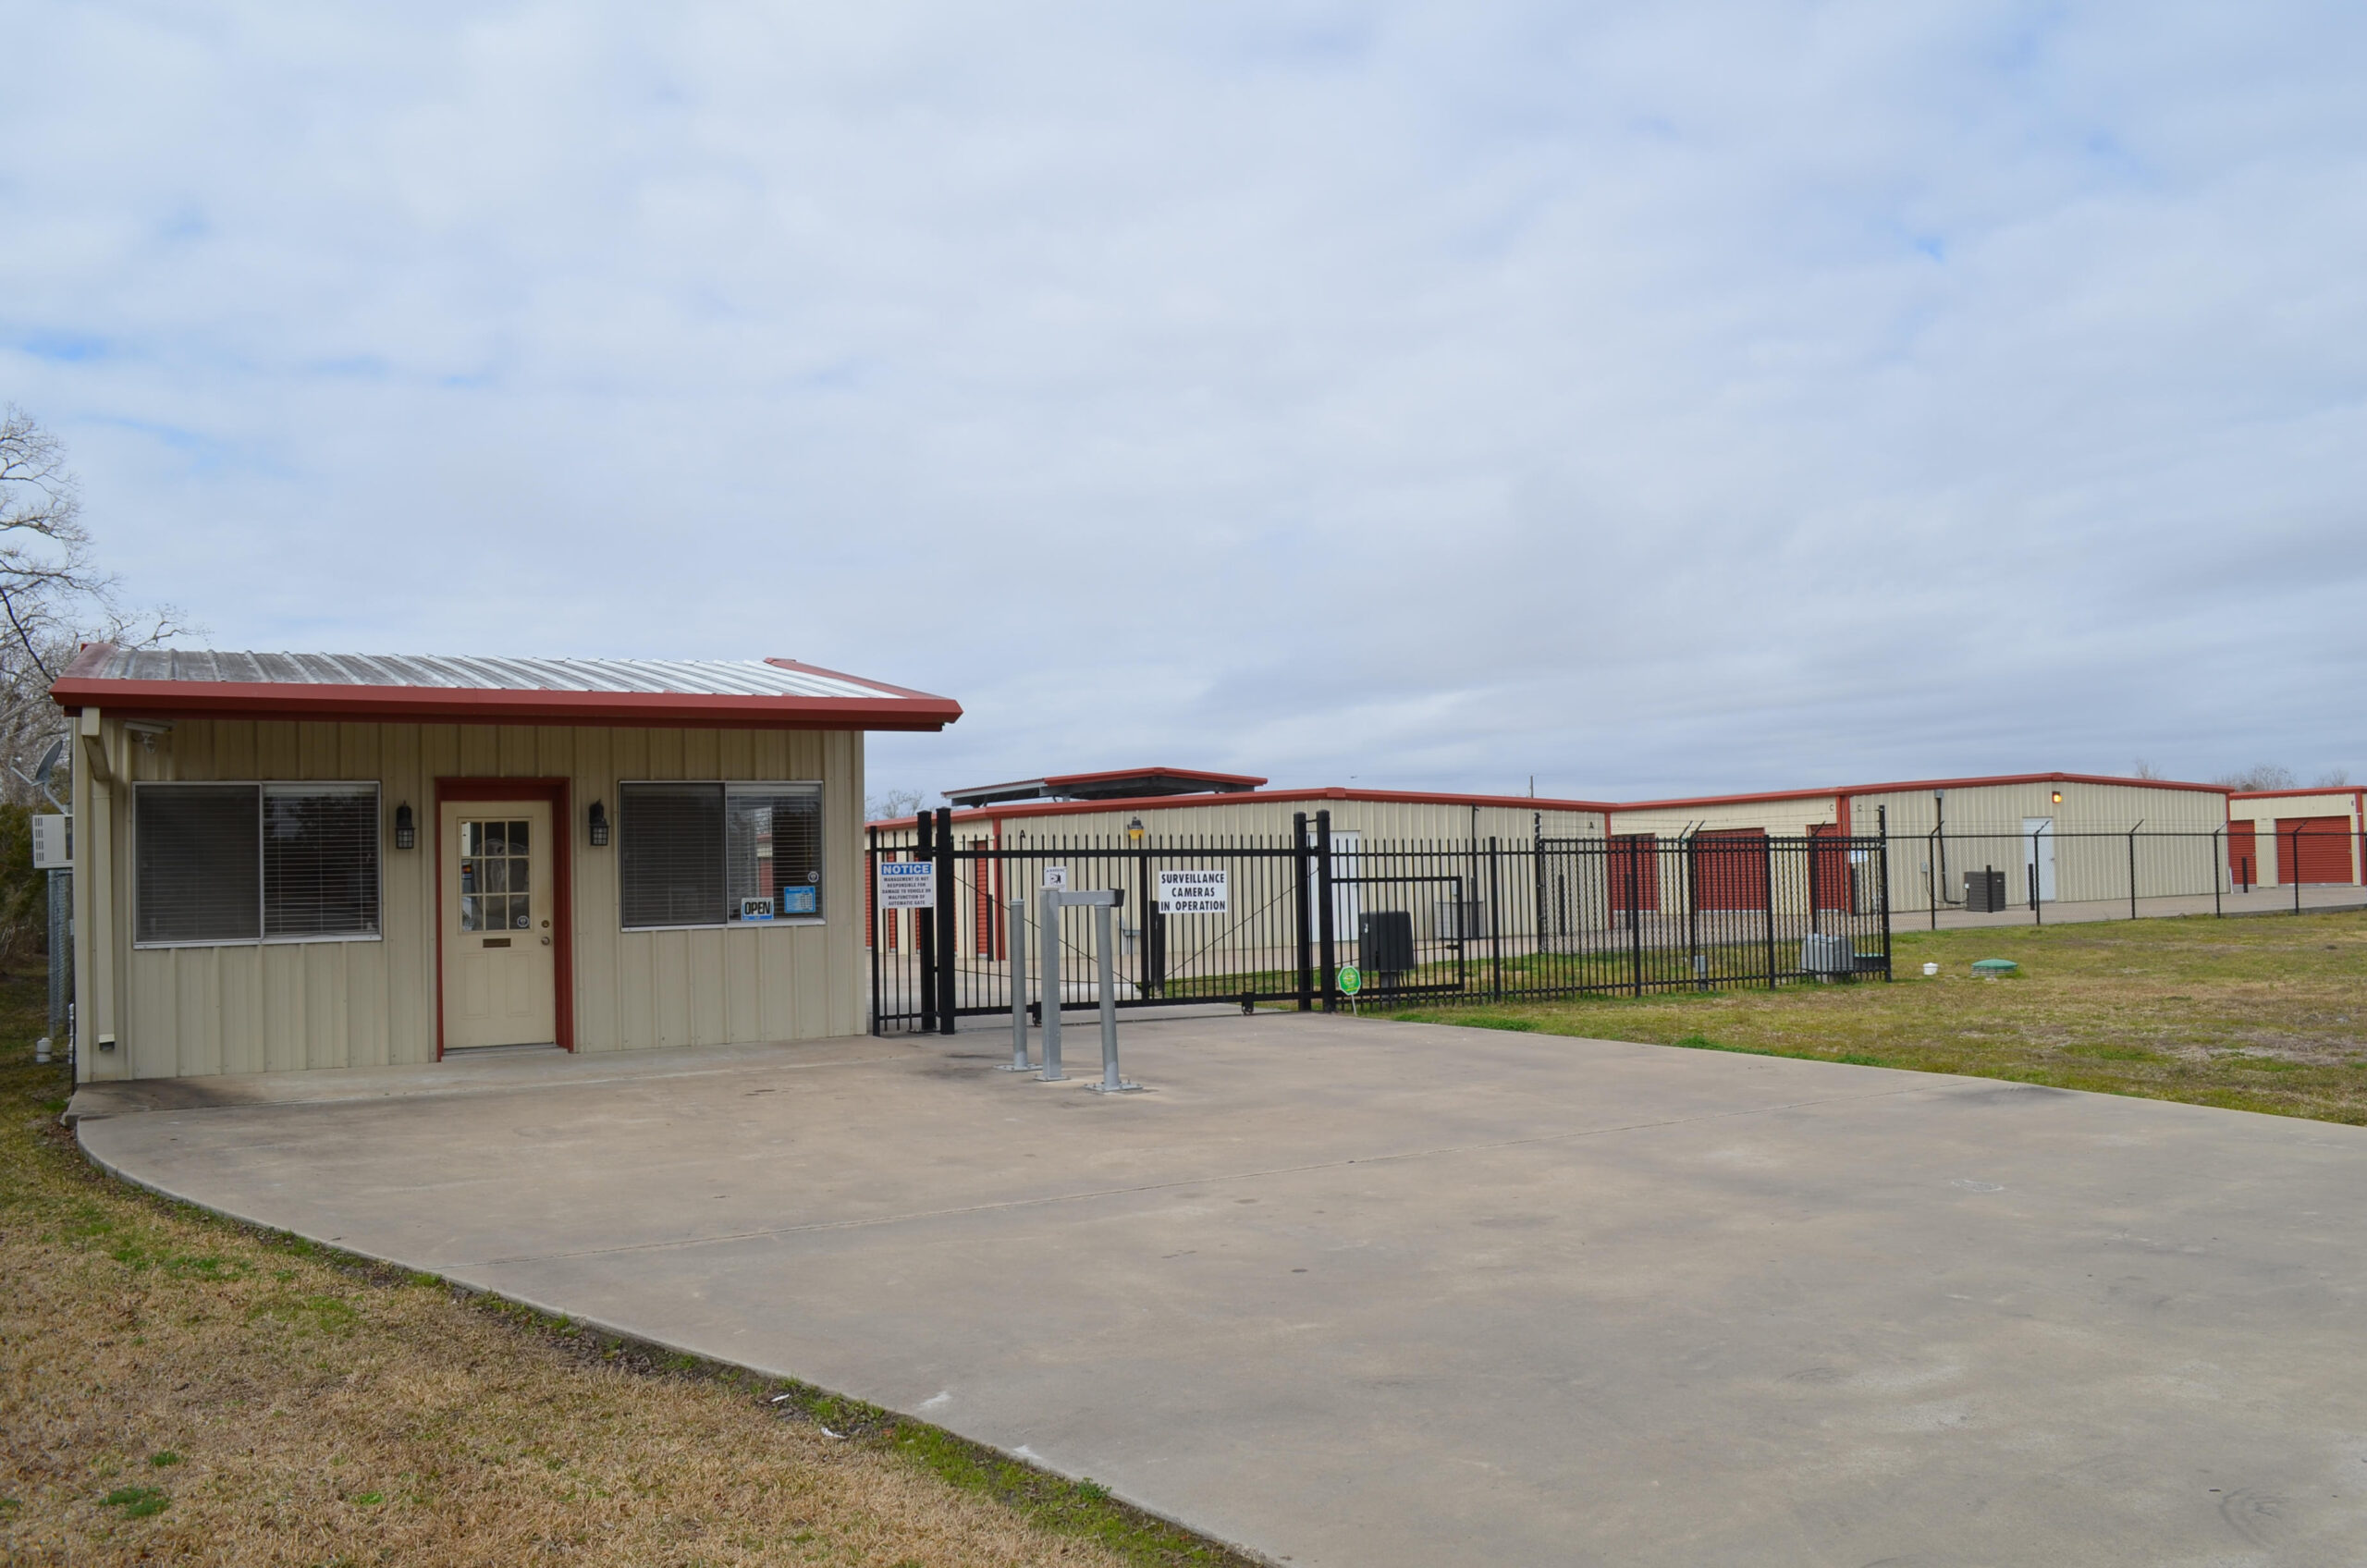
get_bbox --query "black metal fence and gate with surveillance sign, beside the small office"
[864,813,1891,1033]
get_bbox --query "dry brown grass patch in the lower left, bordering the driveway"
[0,986,1238,1568]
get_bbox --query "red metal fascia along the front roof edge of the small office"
[50,658,961,729]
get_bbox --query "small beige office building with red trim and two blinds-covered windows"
[52,644,961,1080]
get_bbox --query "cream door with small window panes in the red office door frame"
[438,801,558,1049]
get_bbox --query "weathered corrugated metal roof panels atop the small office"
[78,649,892,699]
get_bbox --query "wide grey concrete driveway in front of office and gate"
[80,1016,2367,1568]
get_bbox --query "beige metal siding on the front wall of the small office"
[90,720,864,1078]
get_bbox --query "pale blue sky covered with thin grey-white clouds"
[0,0,2367,796]
